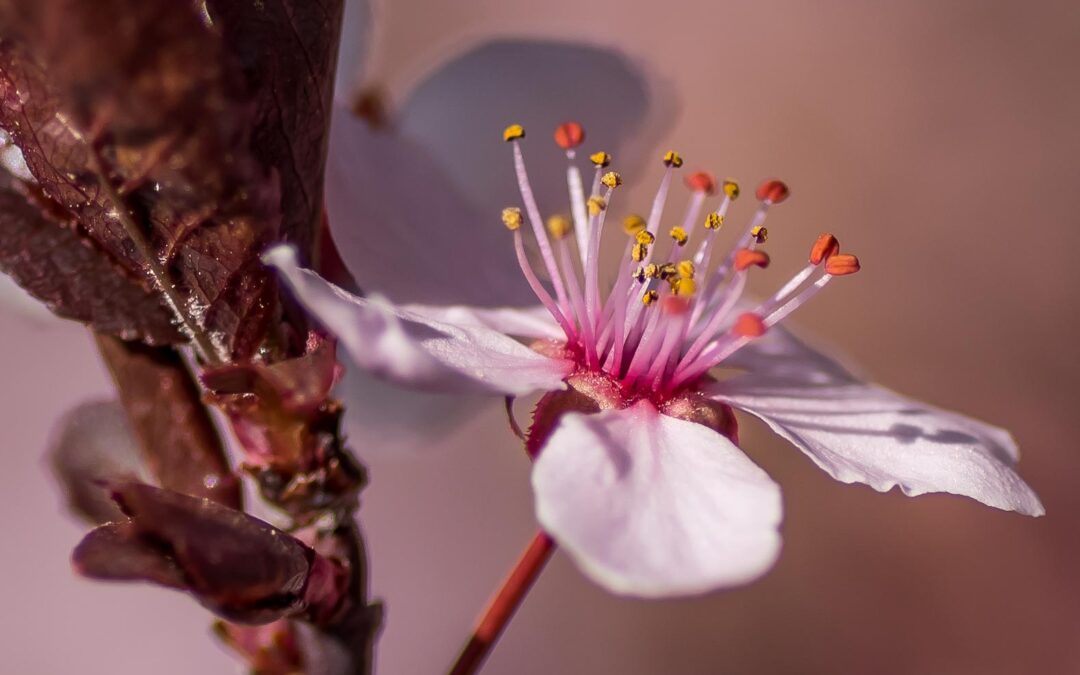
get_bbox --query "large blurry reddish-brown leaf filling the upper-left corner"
[0,0,287,356]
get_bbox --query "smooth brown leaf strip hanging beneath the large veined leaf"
[96,335,241,509]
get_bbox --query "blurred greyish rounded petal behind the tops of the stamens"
[397,39,674,217]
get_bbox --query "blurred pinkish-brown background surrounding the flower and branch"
[0,0,1080,675]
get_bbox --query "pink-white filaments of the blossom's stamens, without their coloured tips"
[501,133,846,395]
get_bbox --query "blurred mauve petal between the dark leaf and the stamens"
[326,102,536,307]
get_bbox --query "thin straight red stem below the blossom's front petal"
[450,531,555,675]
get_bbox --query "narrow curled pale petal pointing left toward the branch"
[264,246,573,396]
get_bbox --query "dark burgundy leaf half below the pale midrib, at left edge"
[0,170,181,345]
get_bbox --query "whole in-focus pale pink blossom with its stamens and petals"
[266,123,1042,596]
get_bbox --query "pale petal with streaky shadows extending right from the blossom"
[706,328,1043,515]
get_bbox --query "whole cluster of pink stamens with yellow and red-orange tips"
[502,122,859,397]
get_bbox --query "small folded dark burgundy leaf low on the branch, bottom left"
[72,483,348,624]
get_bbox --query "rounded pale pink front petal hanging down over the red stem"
[532,402,781,597]
